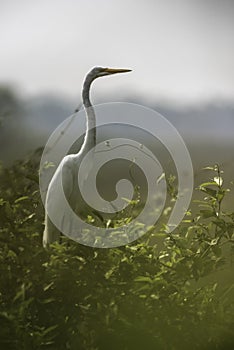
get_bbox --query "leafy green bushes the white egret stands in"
[0,153,234,350]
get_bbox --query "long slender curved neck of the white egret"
[81,75,96,154]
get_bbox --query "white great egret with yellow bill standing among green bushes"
[43,67,131,247]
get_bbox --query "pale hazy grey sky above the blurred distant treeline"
[0,0,234,103]
